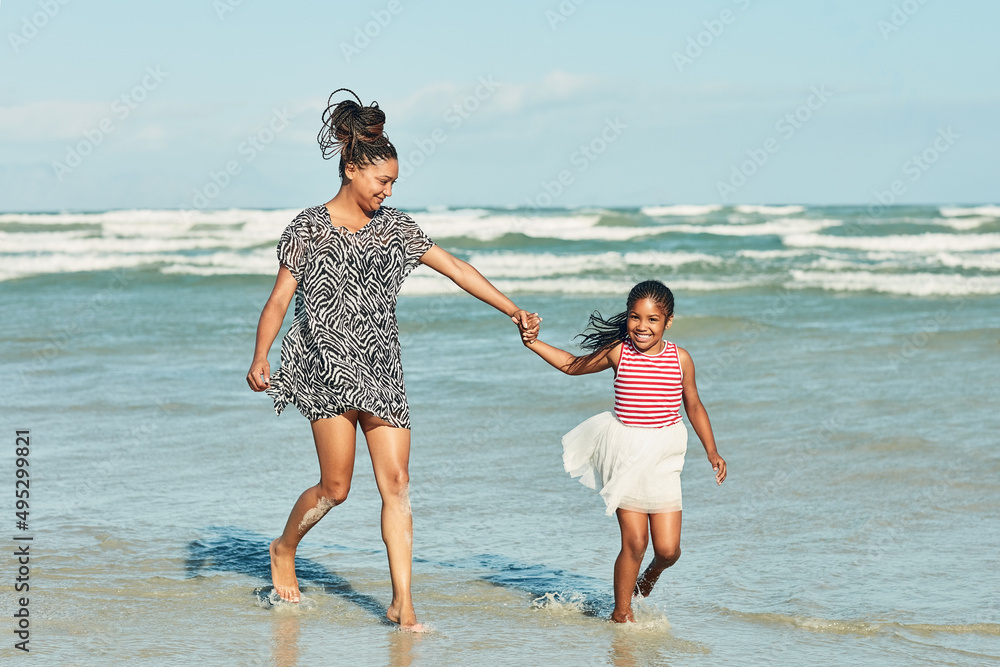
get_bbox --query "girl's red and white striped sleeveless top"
[615,338,683,428]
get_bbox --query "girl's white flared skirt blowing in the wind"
[562,412,687,516]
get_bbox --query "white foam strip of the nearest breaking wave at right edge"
[785,269,1000,296]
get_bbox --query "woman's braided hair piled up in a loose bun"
[316,88,396,180]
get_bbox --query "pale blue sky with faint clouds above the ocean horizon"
[0,0,1000,211]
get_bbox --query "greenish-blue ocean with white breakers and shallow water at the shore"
[0,202,1000,666]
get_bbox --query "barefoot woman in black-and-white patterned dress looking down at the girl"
[247,88,537,631]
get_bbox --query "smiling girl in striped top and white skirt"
[521,280,726,623]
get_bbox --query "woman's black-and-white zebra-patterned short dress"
[266,205,434,429]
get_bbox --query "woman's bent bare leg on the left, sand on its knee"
[271,410,358,602]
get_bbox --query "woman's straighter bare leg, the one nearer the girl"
[360,413,423,632]
